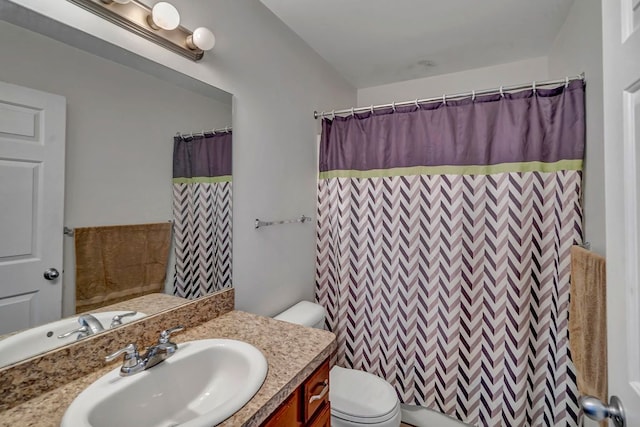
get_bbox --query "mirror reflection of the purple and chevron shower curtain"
[173,132,232,299]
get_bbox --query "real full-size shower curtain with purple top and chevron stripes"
[316,81,585,427]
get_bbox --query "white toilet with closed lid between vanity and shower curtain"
[275,301,401,427]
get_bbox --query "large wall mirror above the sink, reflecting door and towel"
[0,7,232,368]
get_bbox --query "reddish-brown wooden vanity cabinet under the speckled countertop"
[262,360,331,427]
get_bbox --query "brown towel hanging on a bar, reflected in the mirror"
[74,222,171,313]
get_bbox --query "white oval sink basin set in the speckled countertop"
[61,339,267,427]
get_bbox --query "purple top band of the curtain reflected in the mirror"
[173,132,232,179]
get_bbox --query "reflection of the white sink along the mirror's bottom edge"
[0,311,145,367]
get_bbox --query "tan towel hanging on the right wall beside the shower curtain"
[569,246,609,416]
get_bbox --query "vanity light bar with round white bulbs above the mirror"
[67,0,216,61]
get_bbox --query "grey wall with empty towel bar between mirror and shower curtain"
[3,0,356,314]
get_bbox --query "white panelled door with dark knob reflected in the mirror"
[0,82,66,334]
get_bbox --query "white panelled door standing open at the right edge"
[602,0,640,426]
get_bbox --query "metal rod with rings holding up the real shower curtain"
[313,72,585,119]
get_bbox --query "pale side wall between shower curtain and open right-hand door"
[549,0,606,254]
